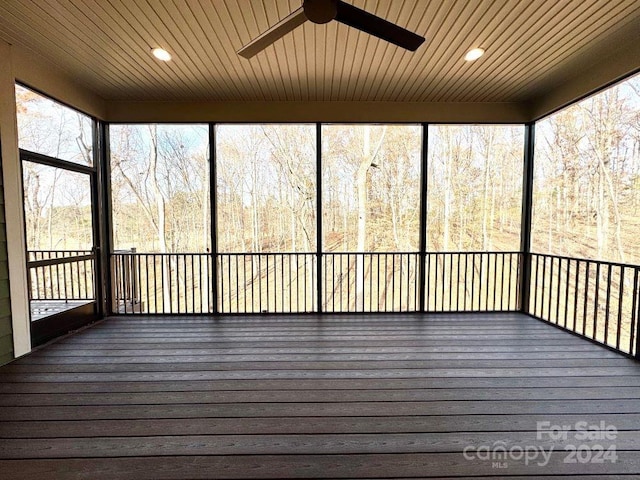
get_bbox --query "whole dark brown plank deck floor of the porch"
[0,314,640,480]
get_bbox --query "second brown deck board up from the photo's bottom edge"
[0,431,640,459]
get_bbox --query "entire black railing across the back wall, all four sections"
[111,250,521,314]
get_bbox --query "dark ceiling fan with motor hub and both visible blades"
[238,0,424,58]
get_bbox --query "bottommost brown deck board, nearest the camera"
[0,451,640,480]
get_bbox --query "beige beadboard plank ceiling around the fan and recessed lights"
[0,0,640,102]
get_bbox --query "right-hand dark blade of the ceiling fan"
[335,1,424,52]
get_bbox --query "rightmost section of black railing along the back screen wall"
[425,252,521,312]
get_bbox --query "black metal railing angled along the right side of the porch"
[528,253,640,356]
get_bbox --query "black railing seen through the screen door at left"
[27,250,95,300]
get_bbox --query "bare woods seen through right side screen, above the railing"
[532,76,640,265]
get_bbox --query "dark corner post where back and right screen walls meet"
[518,122,536,313]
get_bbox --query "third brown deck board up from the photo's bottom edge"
[0,413,640,438]
